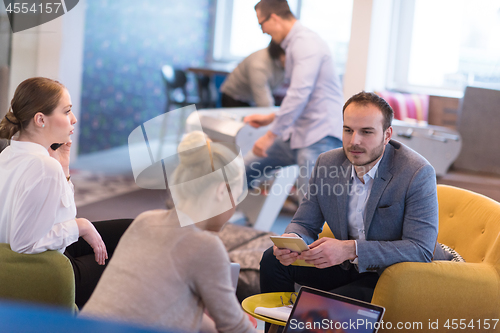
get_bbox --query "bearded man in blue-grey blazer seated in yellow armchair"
[261,92,438,302]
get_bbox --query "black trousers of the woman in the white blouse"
[64,219,133,309]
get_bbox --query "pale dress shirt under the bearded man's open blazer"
[347,160,380,264]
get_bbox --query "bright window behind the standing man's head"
[213,0,353,73]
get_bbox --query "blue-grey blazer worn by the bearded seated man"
[285,140,438,274]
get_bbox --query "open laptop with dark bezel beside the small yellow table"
[284,287,385,333]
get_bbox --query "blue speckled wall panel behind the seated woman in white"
[79,0,215,154]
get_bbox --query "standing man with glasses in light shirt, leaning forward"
[244,0,344,200]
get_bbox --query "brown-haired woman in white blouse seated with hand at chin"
[0,77,131,307]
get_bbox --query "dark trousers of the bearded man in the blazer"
[260,247,379,332]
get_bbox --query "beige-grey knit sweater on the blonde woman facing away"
[81,210,255,333]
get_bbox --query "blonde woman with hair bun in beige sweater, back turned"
[81,132,255,333]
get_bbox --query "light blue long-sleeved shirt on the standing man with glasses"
[270,21,344,149]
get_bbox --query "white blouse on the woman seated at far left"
[0,140,79,253]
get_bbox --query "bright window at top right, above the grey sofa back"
[390,0,500,92]
